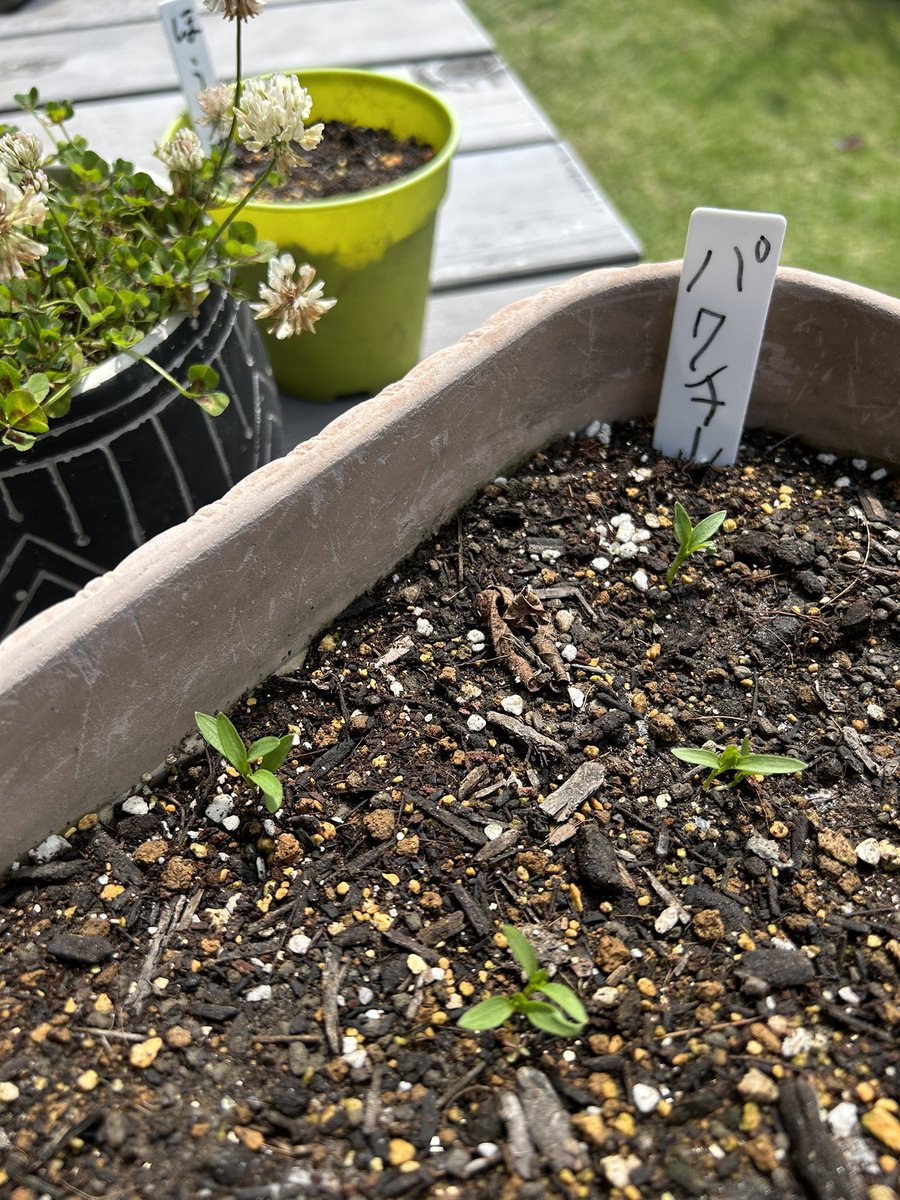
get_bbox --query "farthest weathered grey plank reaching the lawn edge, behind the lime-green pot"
[0,0,491,108]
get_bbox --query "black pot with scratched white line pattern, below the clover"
[0,292,282,636]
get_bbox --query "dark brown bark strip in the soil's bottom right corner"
[778,1079,865,1200]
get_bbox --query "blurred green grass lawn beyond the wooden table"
[468,0,900,295]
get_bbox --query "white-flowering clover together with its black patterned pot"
[0,5,334,636]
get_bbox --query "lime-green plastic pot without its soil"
[218,68,460,401]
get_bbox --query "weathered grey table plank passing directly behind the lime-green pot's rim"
[0,54,554,168]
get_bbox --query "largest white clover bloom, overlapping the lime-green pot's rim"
[235,74,323,172]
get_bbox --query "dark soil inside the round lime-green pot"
[226,121,434,203]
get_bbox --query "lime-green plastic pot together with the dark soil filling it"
[174,51,460,401]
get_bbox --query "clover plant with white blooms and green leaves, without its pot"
[0,0,335,452]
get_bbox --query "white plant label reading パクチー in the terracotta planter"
[653,209,787,467]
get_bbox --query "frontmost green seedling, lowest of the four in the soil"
[457,925,588,1038]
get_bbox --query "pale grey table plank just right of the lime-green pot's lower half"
[432,143,641,289]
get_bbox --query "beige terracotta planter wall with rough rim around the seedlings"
[0,263,900,862]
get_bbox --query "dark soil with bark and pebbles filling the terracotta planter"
[0,426,900,1200]
